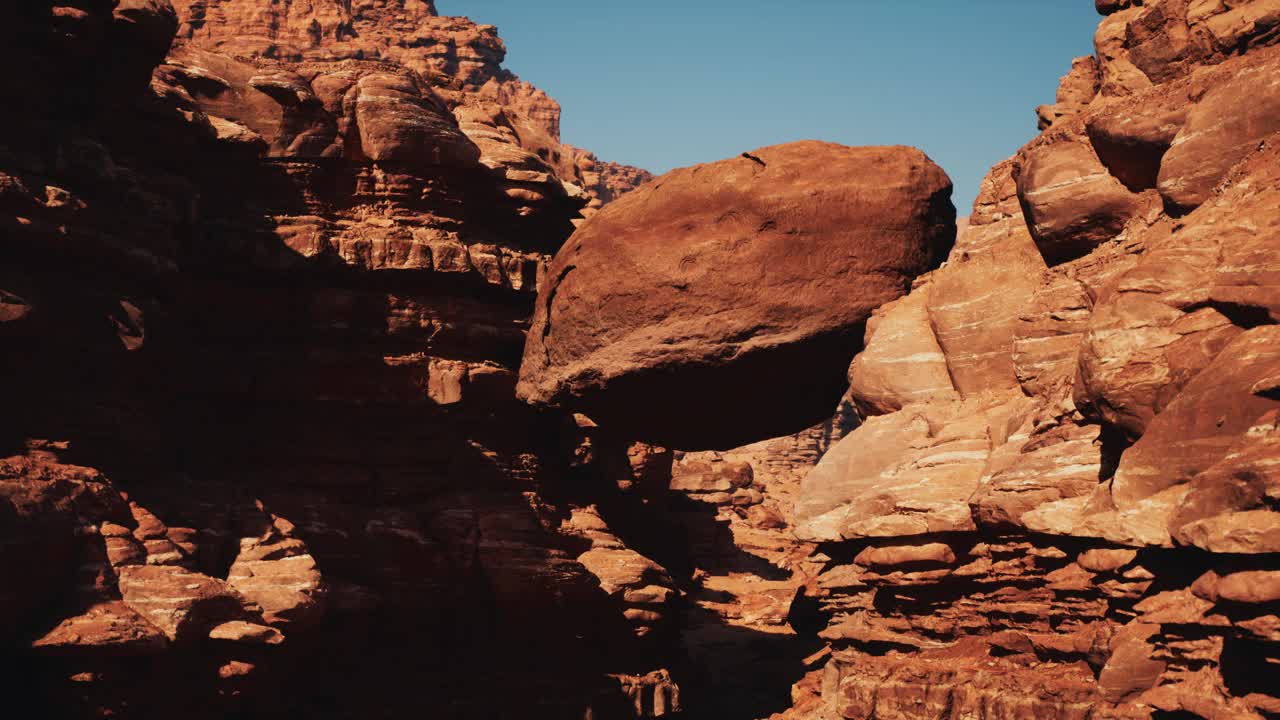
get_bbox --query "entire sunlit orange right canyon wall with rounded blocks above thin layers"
[783,0,1280,720]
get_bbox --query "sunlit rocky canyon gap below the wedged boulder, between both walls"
[668,400,860,717]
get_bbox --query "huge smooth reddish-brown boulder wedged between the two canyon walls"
[517,141,955,450]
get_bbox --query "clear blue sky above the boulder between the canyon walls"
[436,0,1101,215]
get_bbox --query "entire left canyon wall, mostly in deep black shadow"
[0,0,675,717]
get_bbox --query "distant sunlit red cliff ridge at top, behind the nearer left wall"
[167,0,650,214]
